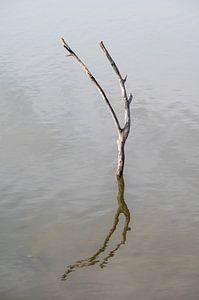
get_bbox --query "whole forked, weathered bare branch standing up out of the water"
[62,38,133,177]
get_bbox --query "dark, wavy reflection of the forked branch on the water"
[61,176,131,280]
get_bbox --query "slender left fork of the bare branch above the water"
[62,38,121,132]
